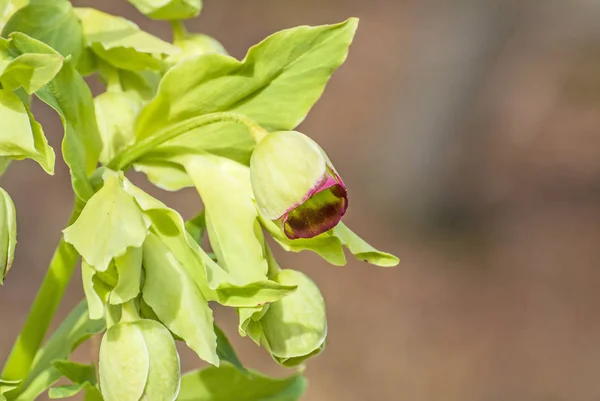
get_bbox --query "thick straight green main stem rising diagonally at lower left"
[2,200,83,380]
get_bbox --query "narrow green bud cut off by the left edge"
[0,188,17,284]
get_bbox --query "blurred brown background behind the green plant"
[0,0,600,401]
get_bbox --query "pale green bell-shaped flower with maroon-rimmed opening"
[250,131,348,239]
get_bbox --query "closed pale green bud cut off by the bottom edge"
[99,311,181,401]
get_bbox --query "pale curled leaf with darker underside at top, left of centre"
[75,8,179,71]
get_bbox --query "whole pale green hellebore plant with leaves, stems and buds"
[0,0,398,401]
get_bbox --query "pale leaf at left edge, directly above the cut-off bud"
[0,89,54,174]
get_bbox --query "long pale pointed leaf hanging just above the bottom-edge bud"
[142,234,219,365]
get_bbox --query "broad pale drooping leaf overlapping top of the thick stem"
[63,170,149,271]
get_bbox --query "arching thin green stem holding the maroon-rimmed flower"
[107,112,268,171]
